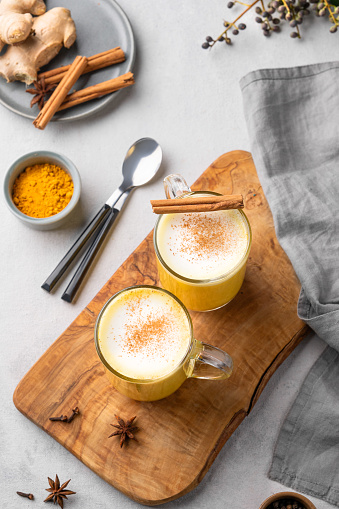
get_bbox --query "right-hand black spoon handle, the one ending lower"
[61,209,120,302]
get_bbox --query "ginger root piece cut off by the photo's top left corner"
[0,0,46,51]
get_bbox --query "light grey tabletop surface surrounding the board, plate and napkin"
[0,0,339,509]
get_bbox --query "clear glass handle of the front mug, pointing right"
[187,341,233,380]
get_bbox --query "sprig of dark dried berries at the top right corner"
[202,0,339,49]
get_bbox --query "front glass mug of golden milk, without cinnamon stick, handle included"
[95,285,233,401]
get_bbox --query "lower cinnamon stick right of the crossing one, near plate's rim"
[58,72,134,111]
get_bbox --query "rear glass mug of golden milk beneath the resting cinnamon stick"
[154,175,252,311]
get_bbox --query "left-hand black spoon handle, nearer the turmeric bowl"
[41,203,112,292]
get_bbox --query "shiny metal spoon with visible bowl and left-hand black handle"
[41,138,162,294]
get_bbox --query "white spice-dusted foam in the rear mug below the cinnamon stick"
[157,206,249,280]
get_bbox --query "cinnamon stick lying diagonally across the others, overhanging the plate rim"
[33,56,88,129]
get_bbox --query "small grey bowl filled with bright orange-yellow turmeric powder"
[4,150,81,230]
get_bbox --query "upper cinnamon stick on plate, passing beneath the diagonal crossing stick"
[38,46,125,85]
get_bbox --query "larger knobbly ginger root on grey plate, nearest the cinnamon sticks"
[0,7,76,85]
